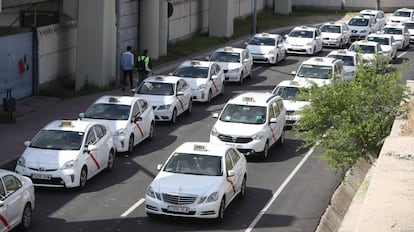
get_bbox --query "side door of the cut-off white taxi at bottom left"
[0,175,23,230]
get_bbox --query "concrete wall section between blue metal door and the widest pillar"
[37,21,78,85]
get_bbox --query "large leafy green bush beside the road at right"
[294,56,409,173]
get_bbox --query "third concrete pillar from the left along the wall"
[208,0,233,37]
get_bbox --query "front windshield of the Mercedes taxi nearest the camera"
[163,152,223,176]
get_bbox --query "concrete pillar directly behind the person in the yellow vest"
[139,0,158,59]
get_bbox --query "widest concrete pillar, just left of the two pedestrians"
[76,0,117,90]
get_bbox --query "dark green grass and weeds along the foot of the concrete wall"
[40,8,347,98]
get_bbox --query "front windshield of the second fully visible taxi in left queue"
[85,104,131,120]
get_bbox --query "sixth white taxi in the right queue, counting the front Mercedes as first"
[348,40,385,62]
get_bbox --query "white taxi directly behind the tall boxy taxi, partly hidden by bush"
[272,80,310,126]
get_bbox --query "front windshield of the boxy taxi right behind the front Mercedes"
[220,104,266,124]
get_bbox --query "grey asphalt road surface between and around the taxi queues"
[13,44,414,232]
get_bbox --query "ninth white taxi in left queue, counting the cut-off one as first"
[319,23,351,48]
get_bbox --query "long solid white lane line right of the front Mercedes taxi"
[245,147,314,232]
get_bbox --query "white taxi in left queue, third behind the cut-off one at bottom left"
[133,75,193,123]
